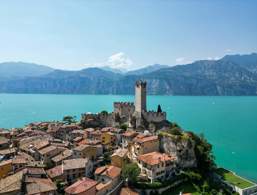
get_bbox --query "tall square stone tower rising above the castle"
[135,80,146,114]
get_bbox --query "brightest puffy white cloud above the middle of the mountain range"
[106,52,133,70]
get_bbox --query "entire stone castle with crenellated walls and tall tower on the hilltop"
[81,80,169,130]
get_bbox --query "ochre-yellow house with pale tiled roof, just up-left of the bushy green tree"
[111,148,128,168]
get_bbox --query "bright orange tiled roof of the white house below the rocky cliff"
[137,152,176,165]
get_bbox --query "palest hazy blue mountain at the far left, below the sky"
[0,62,53,78]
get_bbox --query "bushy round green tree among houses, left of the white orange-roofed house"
[122,163,140,183]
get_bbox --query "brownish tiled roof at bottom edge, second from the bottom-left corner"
[26,178,57,194]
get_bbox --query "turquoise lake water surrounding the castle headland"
[0,94,257,181]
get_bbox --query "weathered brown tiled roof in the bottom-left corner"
[0,171,23,194]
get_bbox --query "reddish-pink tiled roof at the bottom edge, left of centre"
[65,177,97,194]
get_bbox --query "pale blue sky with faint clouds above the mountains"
[0,0,257,70]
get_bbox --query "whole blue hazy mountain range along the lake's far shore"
[0,53,257,96]
